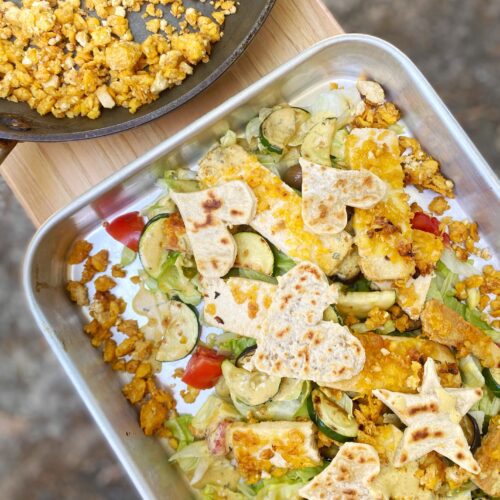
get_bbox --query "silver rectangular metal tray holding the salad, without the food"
[23,35,500,498]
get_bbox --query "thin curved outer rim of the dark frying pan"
[0,0,276,142]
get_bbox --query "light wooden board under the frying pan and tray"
[0,0,342,226]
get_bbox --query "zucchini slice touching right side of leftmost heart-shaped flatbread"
[233,232,274,276]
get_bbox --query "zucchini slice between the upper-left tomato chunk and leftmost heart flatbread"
[139,214,170,279]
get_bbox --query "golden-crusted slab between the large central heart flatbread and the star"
[331,333,461,394]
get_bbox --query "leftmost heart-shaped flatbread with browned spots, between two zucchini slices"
[171,181,256,278]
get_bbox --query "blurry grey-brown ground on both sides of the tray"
[0,0,500,500]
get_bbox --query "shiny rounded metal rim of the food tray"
[22,33,500,498]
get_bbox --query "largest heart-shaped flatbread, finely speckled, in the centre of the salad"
[253,262,365,386]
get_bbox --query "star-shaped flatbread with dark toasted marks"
[373,358,483,474]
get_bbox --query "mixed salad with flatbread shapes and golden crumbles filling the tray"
[67,80,500,499]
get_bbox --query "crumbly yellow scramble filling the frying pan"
[0,0,236,119]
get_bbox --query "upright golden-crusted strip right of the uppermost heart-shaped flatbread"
[346,128,415,281]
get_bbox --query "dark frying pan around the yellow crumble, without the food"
[0,0,275,163]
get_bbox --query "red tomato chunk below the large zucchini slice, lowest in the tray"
[182,346,226,389]
